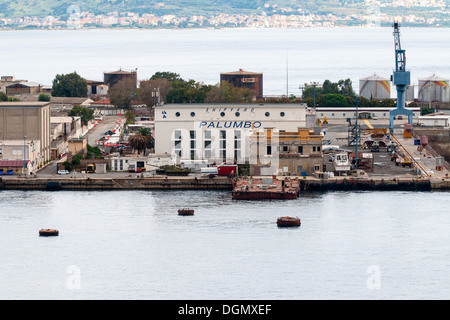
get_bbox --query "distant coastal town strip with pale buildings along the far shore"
[0,0,450,30]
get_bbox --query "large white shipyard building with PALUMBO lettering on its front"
[155,103,315,163]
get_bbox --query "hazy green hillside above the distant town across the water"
[0,0,450,20]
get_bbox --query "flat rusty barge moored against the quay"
[232,177,300,200]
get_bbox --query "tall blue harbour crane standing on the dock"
[389,22,413,133]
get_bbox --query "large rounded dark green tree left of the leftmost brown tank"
[52,72,87,97]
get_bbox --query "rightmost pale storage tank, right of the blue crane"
[418,75,450,102]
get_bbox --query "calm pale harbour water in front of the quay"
[0,191,450,300]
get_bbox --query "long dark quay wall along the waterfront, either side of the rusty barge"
[0,176,450,192]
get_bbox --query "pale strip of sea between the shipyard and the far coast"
[0,28,450,95]
